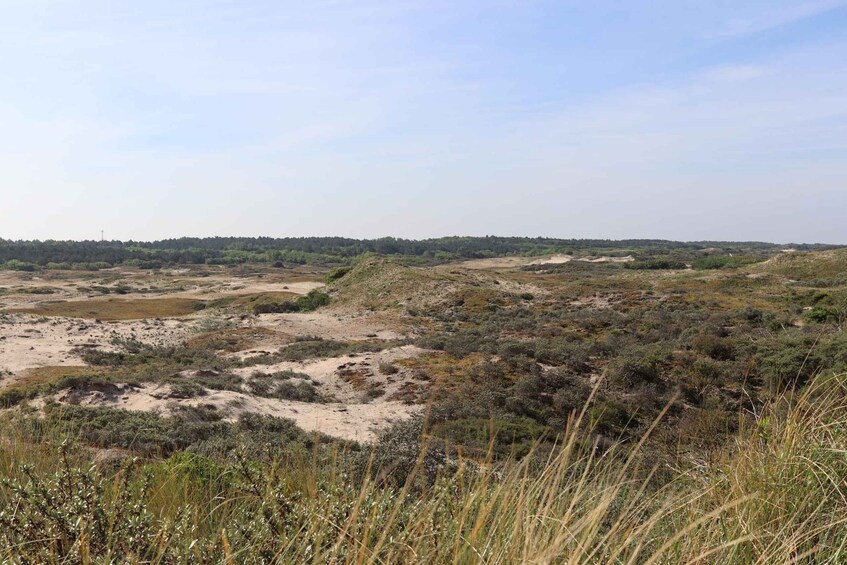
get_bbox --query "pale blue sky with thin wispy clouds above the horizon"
[0,0,847,243]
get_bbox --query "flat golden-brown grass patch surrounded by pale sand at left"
[9,298,203,321]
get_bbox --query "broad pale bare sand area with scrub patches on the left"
[0,269,428,441]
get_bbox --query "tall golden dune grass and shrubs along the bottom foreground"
[0,377,847,564]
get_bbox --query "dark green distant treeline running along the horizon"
[0,236,840,270]
